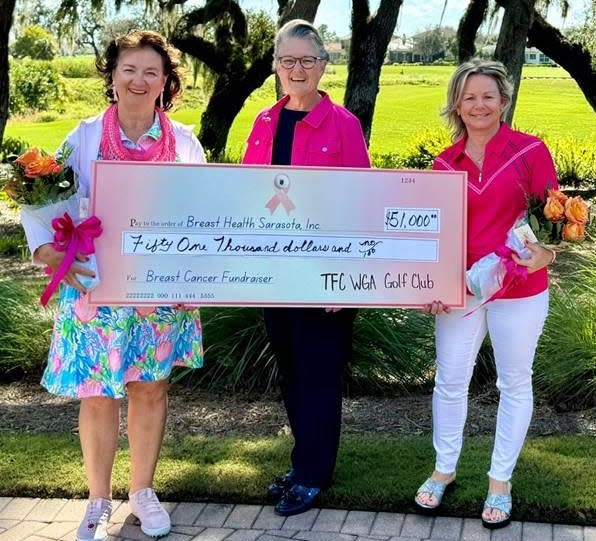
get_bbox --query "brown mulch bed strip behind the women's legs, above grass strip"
[0,382,596,436]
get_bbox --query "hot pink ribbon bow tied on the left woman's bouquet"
[39,212,102,306]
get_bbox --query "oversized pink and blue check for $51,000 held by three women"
[89,161,466,307]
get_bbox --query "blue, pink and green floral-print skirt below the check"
[41,286,203,398]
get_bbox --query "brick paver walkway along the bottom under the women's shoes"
[0,497,596,541]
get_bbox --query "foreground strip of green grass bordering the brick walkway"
[0,434,596,525]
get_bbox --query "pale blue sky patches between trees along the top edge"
[239,0,584,36]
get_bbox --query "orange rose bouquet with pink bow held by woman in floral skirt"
[0,146,101,306]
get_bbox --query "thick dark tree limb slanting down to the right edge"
[528,13,596,112]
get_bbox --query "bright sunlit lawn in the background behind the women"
[6,65,596,155]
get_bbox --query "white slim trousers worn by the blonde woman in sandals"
[433,291,548,481]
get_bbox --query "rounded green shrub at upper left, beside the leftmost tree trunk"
[8,59,64,115]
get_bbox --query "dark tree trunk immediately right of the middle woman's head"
[344,0,402,144]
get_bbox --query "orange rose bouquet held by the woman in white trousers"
[466,189,590,302]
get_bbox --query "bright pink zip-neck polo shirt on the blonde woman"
[433,123,559,299]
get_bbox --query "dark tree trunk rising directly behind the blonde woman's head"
[495,0,536,124]
